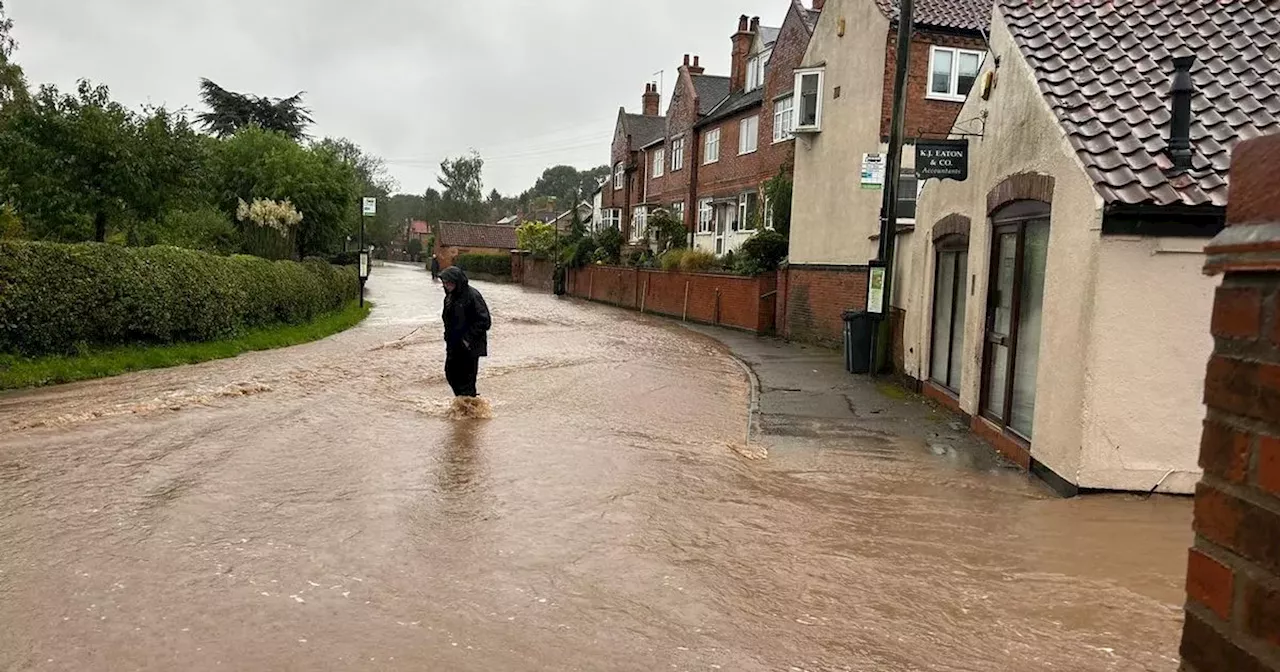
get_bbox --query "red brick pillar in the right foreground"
[1181,136,1280,672]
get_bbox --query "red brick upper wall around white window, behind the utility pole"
[881,29,987,137]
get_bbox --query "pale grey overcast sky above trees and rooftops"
[5,0,790,195]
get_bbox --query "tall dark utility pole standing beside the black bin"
[870,0,915,375]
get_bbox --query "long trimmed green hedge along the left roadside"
[0,241,360,356]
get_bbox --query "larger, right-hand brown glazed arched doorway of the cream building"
[982,200,1050,442]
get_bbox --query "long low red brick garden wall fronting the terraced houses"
[566,266,777,334]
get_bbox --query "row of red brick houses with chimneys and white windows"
[599,0,820,253]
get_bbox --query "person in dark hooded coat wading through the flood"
[440,266,493,397]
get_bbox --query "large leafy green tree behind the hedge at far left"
[0,81,206,242]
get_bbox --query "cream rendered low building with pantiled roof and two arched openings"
[892,0,1280,494]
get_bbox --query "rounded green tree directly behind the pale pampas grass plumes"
[212,127,360,256]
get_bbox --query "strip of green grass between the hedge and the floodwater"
[0,301,372,389]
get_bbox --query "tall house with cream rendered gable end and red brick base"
[778,0,991,343]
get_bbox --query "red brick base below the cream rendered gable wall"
[777,265,868,346]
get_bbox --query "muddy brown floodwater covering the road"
[0,266,1190,672]
